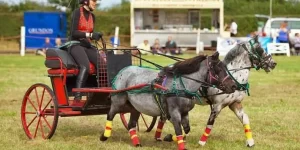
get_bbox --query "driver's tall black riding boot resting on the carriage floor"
[74,66,88,101]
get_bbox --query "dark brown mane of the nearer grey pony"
[162,55,207,75]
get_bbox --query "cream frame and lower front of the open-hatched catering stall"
[130,0,230,47]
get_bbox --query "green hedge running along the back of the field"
[0,0,300,37]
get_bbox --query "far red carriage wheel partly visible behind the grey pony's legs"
[120,113,157,132]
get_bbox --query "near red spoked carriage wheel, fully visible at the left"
[21,83,58,139]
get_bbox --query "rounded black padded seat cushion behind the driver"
[45,48,77,69]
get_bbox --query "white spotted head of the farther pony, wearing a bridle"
[246,36,277,72]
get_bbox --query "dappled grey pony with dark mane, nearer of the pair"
[100,53,236,150]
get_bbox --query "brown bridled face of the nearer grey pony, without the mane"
[207,52,237,93]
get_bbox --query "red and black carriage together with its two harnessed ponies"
[21,37,276,150]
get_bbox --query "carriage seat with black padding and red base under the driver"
[45,48,96,75]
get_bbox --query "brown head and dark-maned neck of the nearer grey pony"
[159,52,237,93]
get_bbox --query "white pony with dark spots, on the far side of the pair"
[158,36,276,147]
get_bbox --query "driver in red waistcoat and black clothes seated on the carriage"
[70,0,102,102]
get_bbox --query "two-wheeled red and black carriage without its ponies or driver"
[21,39,156,139]
